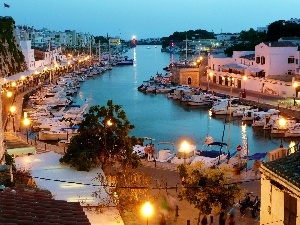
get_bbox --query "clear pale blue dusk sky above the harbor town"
[0,0,300,40]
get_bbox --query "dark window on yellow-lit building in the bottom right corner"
[284,192,297,225]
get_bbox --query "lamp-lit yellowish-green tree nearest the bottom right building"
[178,162,241,224]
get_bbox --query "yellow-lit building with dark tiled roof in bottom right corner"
[260,149,300,225]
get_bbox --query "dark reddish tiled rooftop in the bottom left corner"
[0,187,90,225]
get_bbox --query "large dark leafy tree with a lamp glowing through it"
[60,100,144,171]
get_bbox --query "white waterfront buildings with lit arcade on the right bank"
[207,41,300,97]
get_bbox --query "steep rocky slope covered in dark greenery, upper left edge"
[0,17,27,77]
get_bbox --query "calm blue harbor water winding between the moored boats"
[75,45,289,155]
